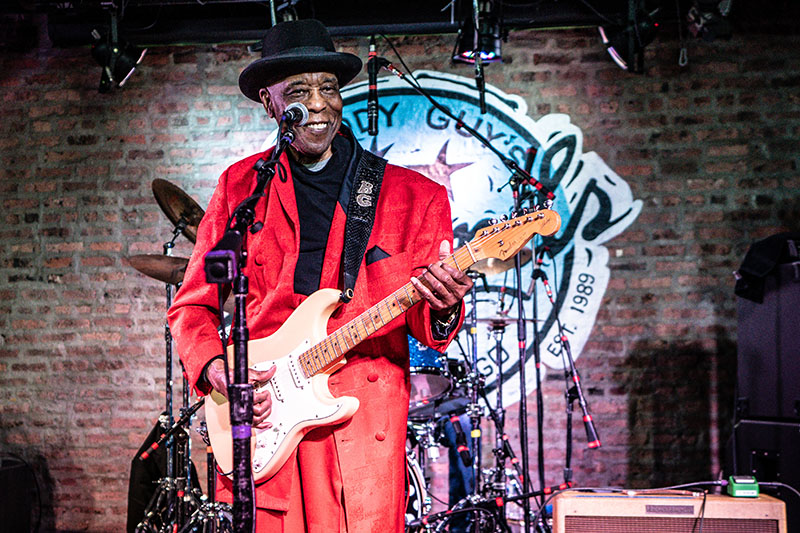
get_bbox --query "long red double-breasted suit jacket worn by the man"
[169,136,463,531]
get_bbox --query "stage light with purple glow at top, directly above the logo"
[453,0,503,63]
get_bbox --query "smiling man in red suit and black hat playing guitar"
[169,20,472,533]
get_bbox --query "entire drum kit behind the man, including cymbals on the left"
[127,179,552,533]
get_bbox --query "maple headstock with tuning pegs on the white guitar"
[469,209,561,262]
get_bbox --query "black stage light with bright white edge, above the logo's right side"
[598,5,658,74]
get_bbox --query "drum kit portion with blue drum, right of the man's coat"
[406,270,531,532]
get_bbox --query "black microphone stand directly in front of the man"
[204,124,294,533]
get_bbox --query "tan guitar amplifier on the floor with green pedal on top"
[553,491,787,533]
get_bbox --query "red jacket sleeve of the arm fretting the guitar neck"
[406,185,464,352]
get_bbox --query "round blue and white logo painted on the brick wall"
[342,71,642,403]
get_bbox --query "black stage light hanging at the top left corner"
[92,12,147,93]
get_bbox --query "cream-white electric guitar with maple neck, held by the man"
[204,209,561,483]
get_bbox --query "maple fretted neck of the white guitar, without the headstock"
[298,244,477,377]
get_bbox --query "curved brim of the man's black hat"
[239,51,362,103]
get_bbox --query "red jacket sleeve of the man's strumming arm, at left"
[167,170,229,394]
